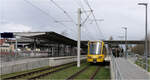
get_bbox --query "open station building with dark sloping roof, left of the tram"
[6,32,87,57]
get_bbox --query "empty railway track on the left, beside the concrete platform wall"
[2,62,76,80]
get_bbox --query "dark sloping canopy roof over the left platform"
[14,32,86,47]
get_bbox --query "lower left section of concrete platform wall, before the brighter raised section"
[0,59,49,74]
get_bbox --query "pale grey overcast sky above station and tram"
[0,0,150,40]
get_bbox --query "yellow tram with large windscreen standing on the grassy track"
[87,41,107,63]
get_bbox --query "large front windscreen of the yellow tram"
[89,42,101,55]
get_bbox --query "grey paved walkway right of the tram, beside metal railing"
[116,58,150,80]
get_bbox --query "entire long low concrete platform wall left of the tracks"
[0,56,86,74]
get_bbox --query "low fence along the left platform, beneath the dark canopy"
[0,51,78,63]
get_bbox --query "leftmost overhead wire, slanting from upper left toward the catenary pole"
[24,0,75,37]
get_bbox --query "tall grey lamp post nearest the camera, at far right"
[138,3,148,71]
